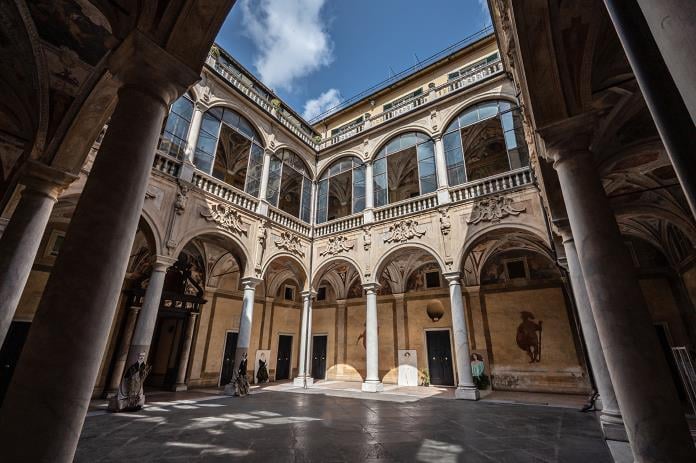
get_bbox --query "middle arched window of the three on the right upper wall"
[372,132,437,207]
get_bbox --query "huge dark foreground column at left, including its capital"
[0,32,198,462]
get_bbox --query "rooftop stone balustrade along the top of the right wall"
[319,59,503,149]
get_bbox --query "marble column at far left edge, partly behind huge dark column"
[0,161,76,346]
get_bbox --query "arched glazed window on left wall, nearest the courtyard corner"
[266,149,312,222]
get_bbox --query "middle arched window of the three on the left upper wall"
[193,107,263,196]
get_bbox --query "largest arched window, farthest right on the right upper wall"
[442,101,529,186]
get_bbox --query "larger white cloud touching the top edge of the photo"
[241,0,333,91]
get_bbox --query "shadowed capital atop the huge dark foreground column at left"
[107,29,200,105]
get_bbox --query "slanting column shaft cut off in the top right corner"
[604,0,696,217]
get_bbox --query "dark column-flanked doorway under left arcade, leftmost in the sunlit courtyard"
[146,316,186,389]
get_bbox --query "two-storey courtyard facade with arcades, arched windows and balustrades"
[6,30,689,404]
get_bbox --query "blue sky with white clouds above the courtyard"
[217,0,490,122]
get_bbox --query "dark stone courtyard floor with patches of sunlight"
[75,387,611,463]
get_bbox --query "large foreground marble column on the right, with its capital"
[542,132,696,463]
